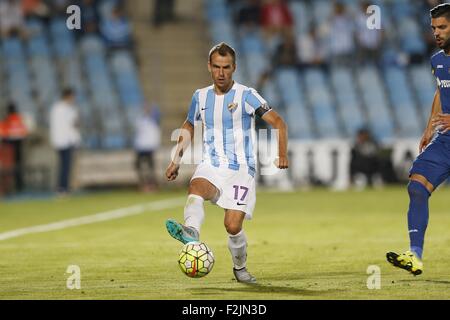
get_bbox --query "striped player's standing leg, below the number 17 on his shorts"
[224,209,256,283]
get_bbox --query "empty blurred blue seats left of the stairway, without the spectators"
[0,0,144,149]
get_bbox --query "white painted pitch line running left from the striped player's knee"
[0,198,186,241]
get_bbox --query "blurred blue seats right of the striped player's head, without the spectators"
[210,0,442,143]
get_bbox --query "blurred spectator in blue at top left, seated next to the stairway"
[100,5,132,49]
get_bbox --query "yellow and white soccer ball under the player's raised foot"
[178,241,214,278]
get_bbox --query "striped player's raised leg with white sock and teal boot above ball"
[166,178,219,243]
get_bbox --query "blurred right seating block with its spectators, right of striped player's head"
[210,0,446,143]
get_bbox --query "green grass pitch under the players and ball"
[0,187,450,300]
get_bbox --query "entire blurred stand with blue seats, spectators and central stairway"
[0,0,443,195]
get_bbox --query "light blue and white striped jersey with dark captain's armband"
[187,82,267,176]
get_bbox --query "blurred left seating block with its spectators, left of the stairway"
[0,0,143,148]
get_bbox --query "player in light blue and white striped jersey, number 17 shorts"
[166,43,289,283]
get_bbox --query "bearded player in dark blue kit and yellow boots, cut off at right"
[386,3,450,275]
